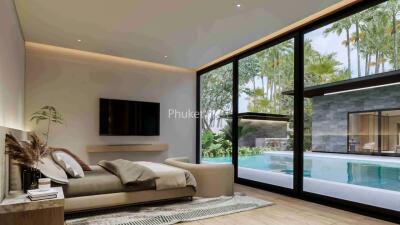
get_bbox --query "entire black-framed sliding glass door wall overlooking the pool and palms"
[197,0,400,218]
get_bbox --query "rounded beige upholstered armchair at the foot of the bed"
[165,157,234,197]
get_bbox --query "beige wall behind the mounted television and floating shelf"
[25,43,196,164]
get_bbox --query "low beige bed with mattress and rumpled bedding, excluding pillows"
[54,159,197,213]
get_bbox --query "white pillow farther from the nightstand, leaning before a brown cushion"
[52,151,85,178]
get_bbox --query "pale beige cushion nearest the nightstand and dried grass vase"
[38,156,68,184]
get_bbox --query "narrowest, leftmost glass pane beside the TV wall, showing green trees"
[200,64,233,163]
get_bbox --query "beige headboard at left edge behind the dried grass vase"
[0,126,27,201]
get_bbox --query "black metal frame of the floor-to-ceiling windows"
[196,0,400,222]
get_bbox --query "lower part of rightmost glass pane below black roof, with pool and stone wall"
[303,88,400,211]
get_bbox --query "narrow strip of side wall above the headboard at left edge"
[0,0,25,130]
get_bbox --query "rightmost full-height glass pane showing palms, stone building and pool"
[303,0,400,211]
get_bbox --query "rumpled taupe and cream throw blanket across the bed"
[98,159,197,190]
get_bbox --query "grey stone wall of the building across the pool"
[312,85,400,152]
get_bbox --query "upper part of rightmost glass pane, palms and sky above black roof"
[304,0,400,87]
